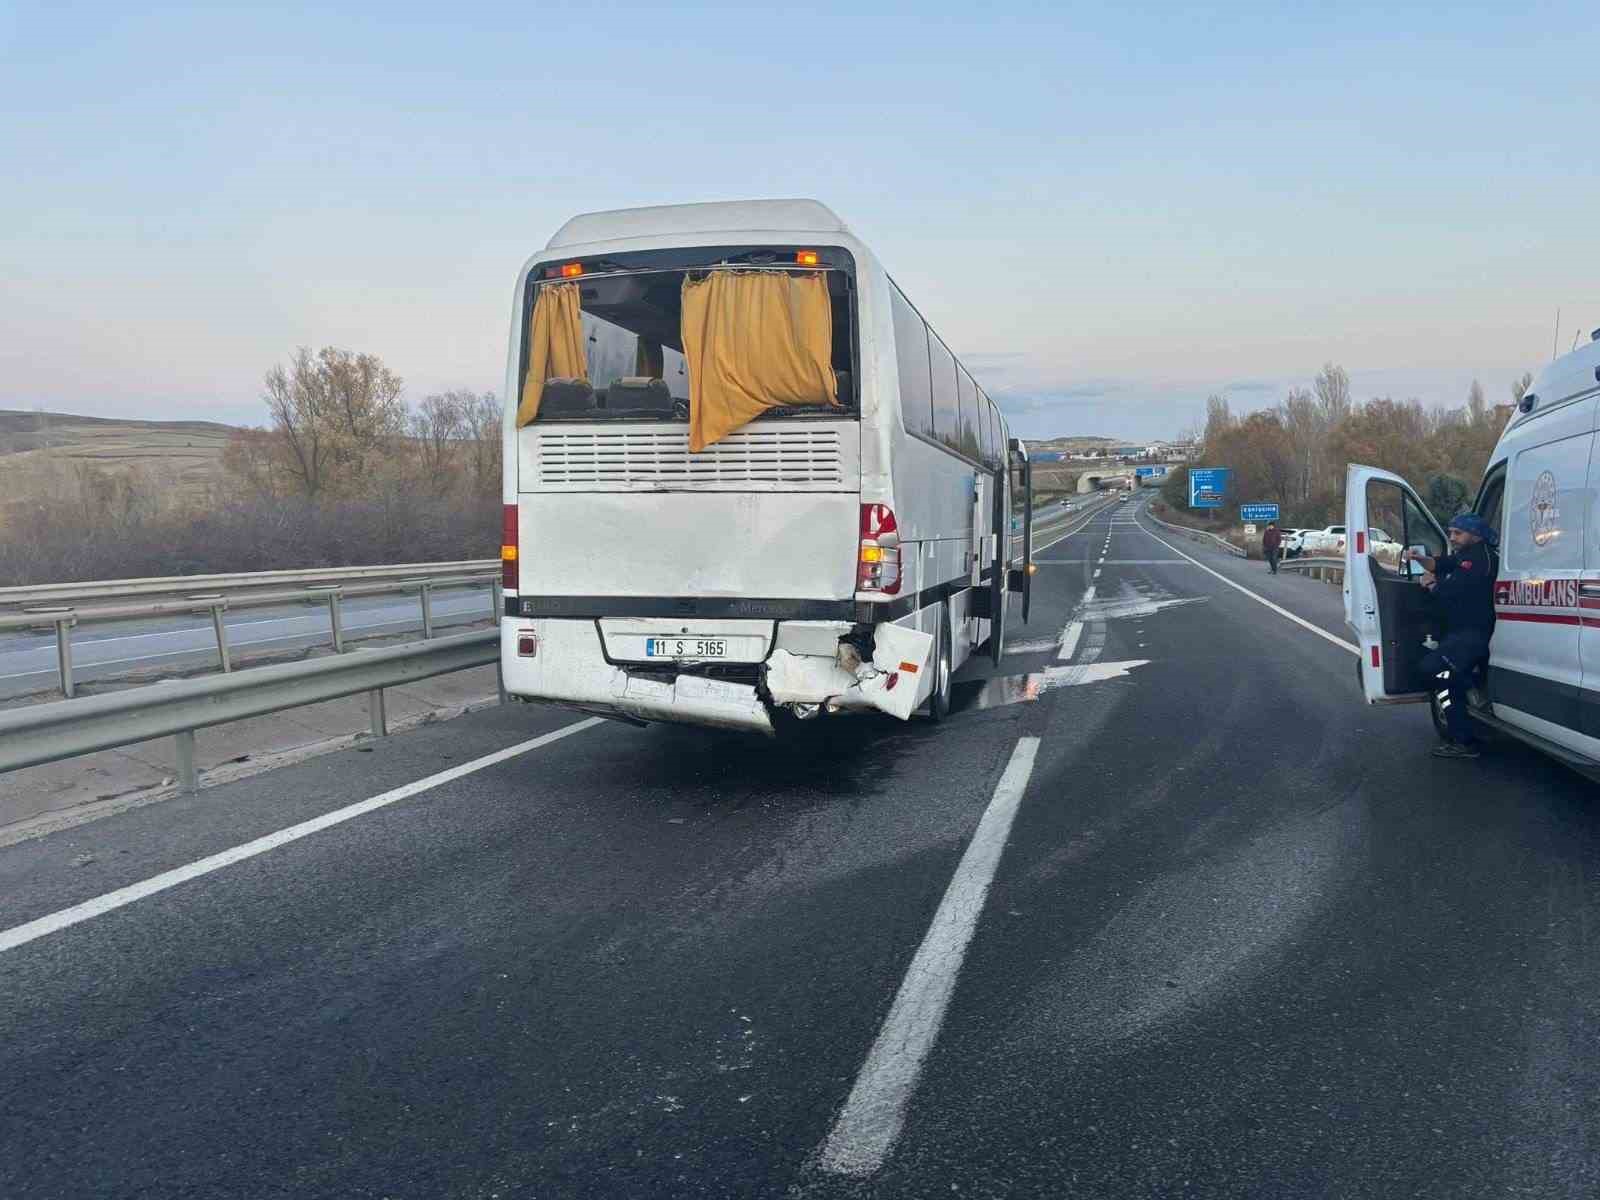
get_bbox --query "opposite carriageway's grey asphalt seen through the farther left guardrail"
[0,587,493,698]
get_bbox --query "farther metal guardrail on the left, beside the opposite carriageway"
[0,572,504,699]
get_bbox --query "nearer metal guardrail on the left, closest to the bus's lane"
[0,629,506,792]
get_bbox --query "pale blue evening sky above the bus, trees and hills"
[0,0,1600,438]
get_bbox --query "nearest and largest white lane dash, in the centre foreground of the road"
[819,738,1038,1178]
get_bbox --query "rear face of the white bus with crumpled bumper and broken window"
[502,202,917,733]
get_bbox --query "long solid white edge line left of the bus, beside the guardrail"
[0,717,603,954]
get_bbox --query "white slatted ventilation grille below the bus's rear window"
[536,429,845,488]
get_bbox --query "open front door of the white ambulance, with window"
[1344,462,1448,704]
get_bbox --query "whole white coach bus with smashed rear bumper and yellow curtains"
[501,200,1032,733]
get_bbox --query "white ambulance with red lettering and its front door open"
[1344,330,1600,778]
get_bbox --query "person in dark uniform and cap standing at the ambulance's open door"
[1400,512,1499,758]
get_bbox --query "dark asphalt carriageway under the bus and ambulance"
[0,506,1600,1200]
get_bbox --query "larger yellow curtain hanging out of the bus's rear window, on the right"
[683,270,838,451]
